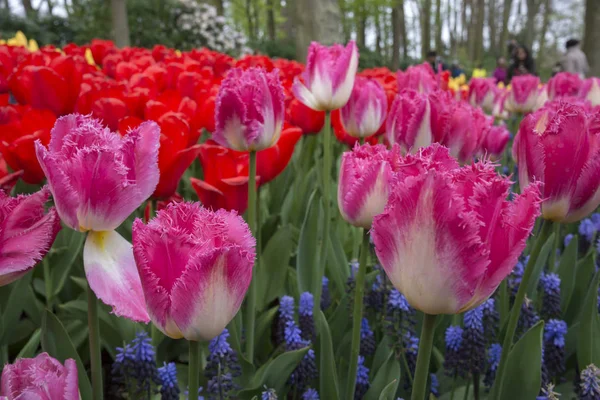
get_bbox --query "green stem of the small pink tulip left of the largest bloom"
[346,229,369,399]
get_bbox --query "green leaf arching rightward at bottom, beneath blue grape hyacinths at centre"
[238,347,309,398]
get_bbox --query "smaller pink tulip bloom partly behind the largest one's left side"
[338,144,401,229]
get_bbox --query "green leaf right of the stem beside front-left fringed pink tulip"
[255,227,293,310]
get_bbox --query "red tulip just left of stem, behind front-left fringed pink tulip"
[190,141,258,214]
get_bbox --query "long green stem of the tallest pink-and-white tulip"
[313,111,333,312]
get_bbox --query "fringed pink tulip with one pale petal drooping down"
[36,114,160,322]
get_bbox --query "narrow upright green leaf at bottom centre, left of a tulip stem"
[316,310,340,400]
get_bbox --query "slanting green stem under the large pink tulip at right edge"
[490,220,552,400]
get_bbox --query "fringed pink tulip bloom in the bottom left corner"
[0,353,79,400]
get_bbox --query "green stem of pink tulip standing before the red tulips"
[246,151,260,363]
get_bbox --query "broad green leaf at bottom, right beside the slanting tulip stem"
[499,321,544,400]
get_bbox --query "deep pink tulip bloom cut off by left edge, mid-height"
[0,187,60,286]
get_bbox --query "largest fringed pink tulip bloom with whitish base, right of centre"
[372,144,540,314]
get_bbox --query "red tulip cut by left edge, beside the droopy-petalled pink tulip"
[0,106,56,184]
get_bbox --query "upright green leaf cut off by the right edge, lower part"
[577,272,600,369]
